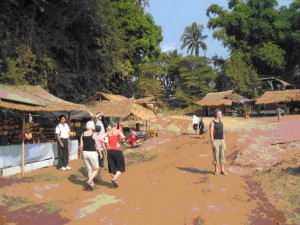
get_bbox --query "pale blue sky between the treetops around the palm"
[146,0,292,58]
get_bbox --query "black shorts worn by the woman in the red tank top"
[107,150,125,174]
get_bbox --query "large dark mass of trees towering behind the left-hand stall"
[0,0,162,102]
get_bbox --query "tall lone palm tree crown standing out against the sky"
[180,22,208,56]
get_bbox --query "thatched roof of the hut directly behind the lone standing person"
[194,90,245,106]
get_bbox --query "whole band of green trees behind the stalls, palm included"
[0,0,300,107]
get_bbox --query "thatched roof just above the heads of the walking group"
[86,99,156,120]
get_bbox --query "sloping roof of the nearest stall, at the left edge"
[0,84,85,111]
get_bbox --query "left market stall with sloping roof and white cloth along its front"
[0,84,86,175]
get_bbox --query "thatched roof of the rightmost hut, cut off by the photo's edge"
[255,89,300,105]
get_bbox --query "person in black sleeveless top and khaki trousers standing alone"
[209,109,227,175]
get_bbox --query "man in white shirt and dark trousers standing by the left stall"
[55,115,71,171]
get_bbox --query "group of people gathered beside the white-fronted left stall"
[56,113,125,190]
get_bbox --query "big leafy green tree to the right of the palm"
[207,0,300,80]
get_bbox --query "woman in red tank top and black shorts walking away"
[100,123,125,188]
